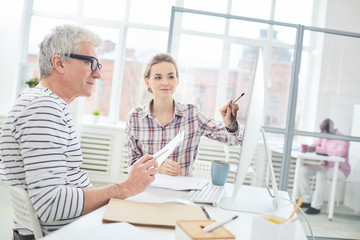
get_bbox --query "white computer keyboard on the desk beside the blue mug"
[185,183,225,207]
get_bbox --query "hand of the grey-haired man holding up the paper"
[124,155,158,197]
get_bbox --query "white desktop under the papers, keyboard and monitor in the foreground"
[42,184,307,240]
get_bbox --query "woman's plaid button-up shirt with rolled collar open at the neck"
[125,100,242,175]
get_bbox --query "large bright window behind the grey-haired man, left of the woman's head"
[19,0,175,123]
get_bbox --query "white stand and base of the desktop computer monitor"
[220,128,279,213]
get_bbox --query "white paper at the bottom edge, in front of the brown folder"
[44,222,158,240]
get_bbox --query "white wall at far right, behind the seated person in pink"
[316,0,360,135]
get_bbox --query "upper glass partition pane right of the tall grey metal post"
[295,30,360,135]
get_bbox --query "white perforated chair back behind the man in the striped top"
[7,186,43,239]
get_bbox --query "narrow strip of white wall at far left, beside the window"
[0,0,24,113]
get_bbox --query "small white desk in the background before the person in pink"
[291,153,345,221]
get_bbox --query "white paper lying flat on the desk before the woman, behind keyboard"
[150,173,210,190]
